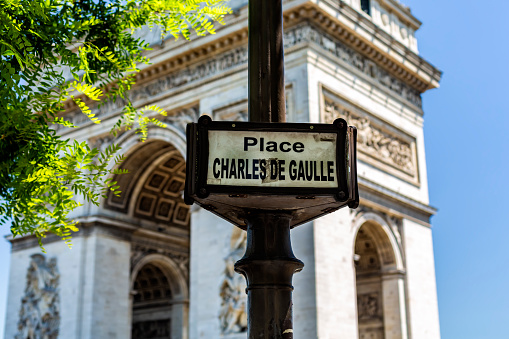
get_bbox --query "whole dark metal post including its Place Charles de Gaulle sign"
[184,0,359,339]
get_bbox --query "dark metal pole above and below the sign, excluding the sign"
[235,0,304,339]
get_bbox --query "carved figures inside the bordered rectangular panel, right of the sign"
[324,93,417,181]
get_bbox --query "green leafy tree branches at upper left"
[0,0,230,250]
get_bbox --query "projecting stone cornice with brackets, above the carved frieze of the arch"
[65,0,441,115]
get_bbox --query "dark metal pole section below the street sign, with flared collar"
[235,211,304,339]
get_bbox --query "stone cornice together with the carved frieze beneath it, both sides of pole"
[56,1,441,129]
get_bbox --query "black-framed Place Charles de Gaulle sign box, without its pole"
[184,116,359,228]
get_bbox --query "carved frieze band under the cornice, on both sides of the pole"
[59,20,422,132]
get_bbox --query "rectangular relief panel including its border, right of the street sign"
[322,91,418,184]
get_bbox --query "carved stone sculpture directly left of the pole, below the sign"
[219,227,247,334]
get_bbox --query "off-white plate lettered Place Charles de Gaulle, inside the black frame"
[207,130,338,188]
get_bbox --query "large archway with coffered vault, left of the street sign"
[103,130,190,339]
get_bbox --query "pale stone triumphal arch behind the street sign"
[5,0,441,339]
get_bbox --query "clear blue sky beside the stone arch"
[0,0,509,339]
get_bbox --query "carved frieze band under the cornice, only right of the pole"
[284,25,422,107]
